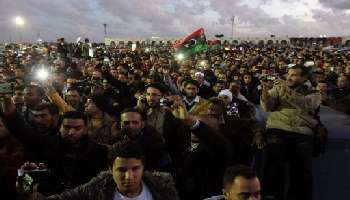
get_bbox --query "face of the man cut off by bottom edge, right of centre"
[224,176,261,200]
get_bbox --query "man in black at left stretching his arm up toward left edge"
[1,96,107,194]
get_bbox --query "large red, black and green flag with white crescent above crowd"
[173,28,208,56]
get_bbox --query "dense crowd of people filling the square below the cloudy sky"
[0,38,350,200]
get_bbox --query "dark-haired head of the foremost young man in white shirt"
[108,140,145,198]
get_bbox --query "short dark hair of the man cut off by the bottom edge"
[223,165,257,189]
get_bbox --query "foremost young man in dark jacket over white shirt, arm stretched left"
[17,141,179,200]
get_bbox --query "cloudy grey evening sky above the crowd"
[0,0,350,42]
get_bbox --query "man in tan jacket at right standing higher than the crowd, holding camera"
[261,65,321,200]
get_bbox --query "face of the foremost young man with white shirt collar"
[112,157,144,197]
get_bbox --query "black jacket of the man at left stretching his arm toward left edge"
[3,113,108,194]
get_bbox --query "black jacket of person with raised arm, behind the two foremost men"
[178,122,232,200]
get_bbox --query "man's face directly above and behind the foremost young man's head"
[120,112,145,138]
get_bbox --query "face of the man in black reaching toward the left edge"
[60,119,87,145]
